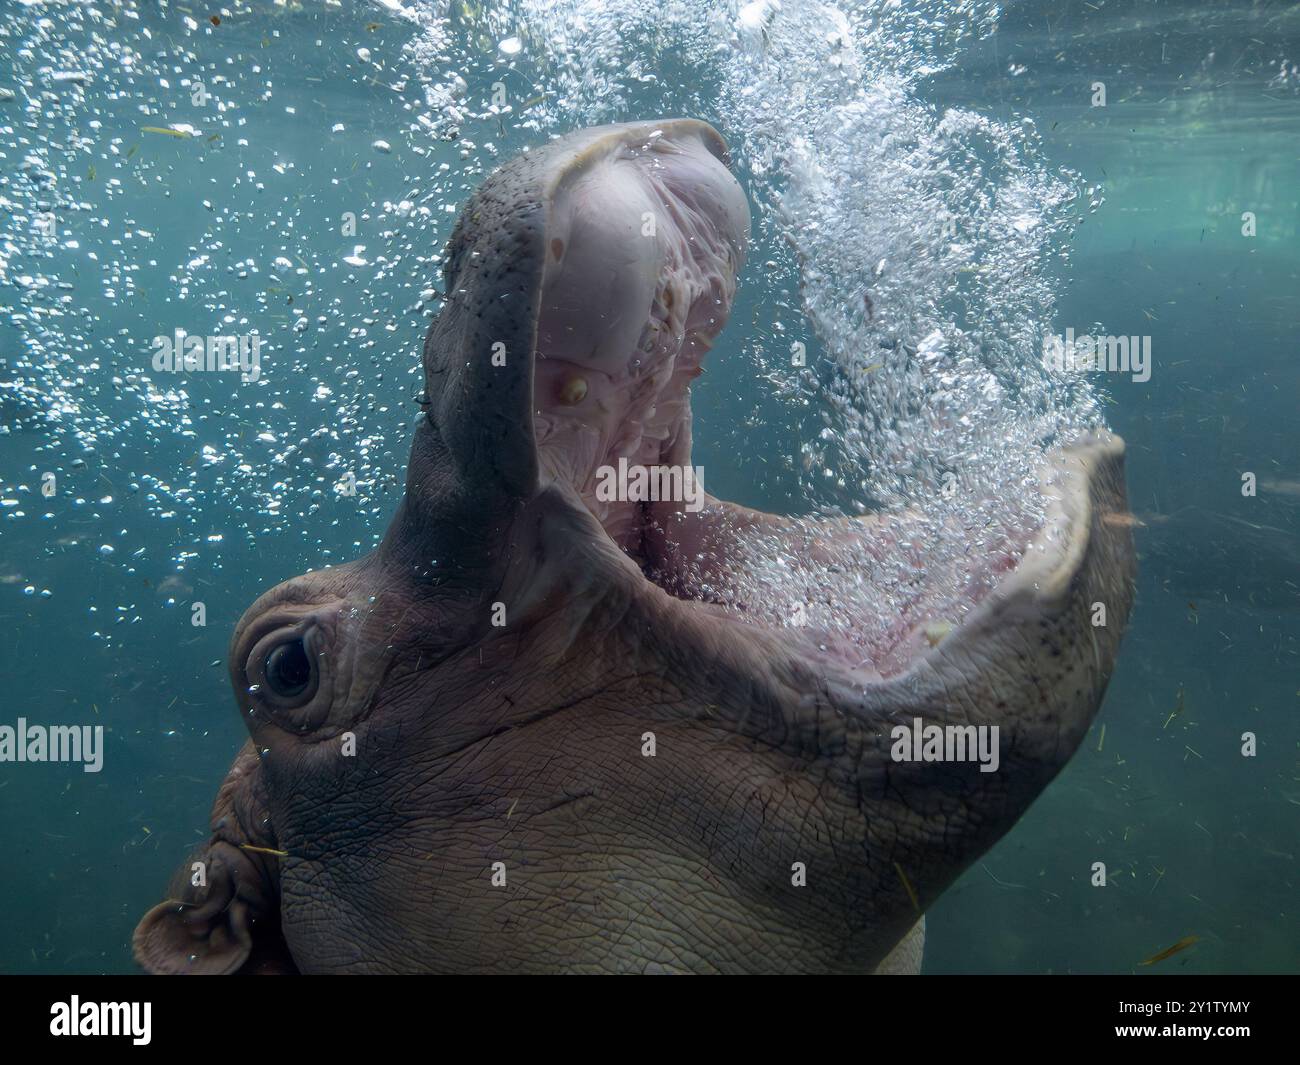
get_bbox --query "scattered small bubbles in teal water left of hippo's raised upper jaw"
[0,3,447,587]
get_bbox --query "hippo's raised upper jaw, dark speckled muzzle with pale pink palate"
[408,120,749,561]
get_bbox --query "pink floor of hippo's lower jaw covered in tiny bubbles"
[646,502,1037,677]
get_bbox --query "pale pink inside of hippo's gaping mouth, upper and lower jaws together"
[449,120,1121,677]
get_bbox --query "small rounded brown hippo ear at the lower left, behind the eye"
[133,843,274,975]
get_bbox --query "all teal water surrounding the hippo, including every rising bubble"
[0,0,1300,973]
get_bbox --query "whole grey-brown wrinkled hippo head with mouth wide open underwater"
[126,120,1134,973]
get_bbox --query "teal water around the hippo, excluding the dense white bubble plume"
[0,3,1300,973]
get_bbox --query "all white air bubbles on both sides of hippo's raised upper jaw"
[0,0,1100,644]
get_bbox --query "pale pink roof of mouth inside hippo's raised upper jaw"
[533,130,749,551]
